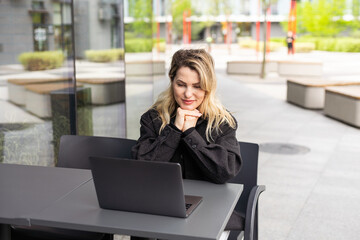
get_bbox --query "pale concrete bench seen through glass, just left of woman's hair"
[125,60,165,76]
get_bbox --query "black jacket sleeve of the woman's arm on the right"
[184,125,241,183]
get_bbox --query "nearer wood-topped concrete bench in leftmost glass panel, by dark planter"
[25,83,81,118]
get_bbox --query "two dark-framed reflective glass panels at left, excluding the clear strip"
[0,0,126,166]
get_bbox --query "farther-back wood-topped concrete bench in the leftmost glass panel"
[7,78,71,105]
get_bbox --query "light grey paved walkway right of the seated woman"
[213,45,360,240]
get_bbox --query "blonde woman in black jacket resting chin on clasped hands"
[133,49,242,240]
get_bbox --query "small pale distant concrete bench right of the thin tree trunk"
[277,61,323,77]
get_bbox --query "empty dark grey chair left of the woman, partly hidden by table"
[11,135,136,240]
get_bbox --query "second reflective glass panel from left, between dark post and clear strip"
[74,0,126,137]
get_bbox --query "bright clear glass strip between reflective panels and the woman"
[124,0,166,139]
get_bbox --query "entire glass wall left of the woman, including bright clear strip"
[0,0,180,166]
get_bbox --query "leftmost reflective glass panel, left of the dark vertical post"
[0,0,75,166]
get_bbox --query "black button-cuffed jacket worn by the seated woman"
[132,109,243,230]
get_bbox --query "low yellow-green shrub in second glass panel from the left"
[85,48,124,62]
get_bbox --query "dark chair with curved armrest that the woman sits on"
[228,142,265,240]
